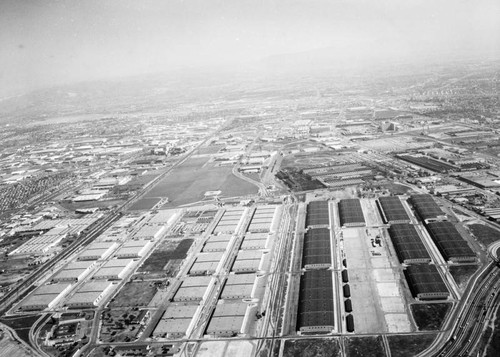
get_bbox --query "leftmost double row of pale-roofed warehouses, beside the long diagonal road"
[17,211,181,311]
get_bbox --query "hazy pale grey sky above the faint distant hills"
[0,0,500,97]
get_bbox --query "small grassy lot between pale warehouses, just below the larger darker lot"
[109,281,156,308]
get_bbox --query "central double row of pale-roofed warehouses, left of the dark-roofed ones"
[153,205,281,338]
